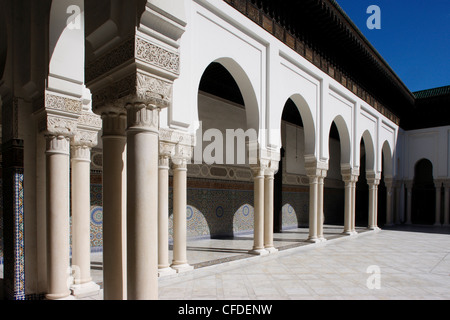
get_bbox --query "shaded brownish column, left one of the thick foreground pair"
[102,108,127,300]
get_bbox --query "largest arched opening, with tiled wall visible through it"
[192,59,257,238]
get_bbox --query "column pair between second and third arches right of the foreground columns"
[305,162,328,243]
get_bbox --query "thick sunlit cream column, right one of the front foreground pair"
[126,103,159,300]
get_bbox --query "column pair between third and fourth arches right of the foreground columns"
[342,169,359,236]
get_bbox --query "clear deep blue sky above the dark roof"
[336,0,450,92]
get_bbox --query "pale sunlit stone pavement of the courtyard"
[83,226,450,300]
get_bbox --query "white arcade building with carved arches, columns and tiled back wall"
[0,0,450,300]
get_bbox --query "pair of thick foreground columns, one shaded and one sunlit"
[100,102,159,300]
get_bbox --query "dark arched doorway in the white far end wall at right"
[411,159,436,225]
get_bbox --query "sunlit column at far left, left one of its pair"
[46,135,70,300]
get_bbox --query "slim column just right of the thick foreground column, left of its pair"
[158,153,176,277]
